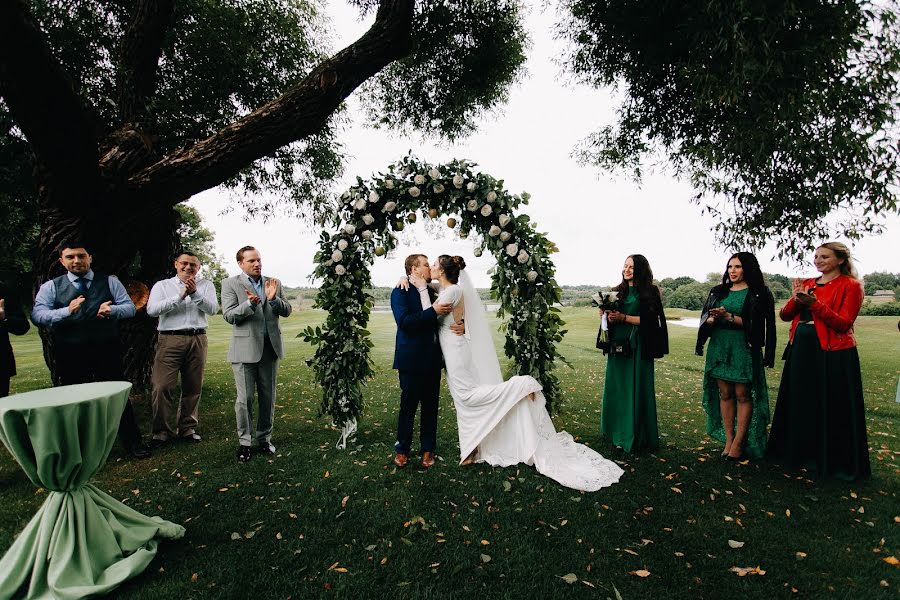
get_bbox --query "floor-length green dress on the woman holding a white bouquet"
[600,293,659,452]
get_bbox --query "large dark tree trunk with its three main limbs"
[8,0,414,388]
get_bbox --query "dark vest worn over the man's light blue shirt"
[50,272,119,344]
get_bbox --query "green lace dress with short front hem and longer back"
[703,289,769,459]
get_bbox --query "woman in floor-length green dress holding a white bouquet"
[600,254,669,452]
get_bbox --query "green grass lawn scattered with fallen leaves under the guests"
[0,308,900,600]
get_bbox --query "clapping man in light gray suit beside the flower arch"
[222,246,291,462]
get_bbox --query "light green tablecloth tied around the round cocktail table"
[0,381,184,599]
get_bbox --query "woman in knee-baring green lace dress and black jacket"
[696,252,775,460]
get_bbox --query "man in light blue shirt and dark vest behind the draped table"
[31,242,150,458]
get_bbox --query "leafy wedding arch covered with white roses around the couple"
[300,156,565,442]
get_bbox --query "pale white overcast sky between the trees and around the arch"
[191,2,900,287]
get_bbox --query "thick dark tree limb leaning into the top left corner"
[0,0,98,184]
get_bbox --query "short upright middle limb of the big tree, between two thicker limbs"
[116,0,175,123]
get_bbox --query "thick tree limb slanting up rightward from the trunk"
[127,0,414,208]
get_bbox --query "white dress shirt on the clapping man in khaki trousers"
[147,276,219,331]
